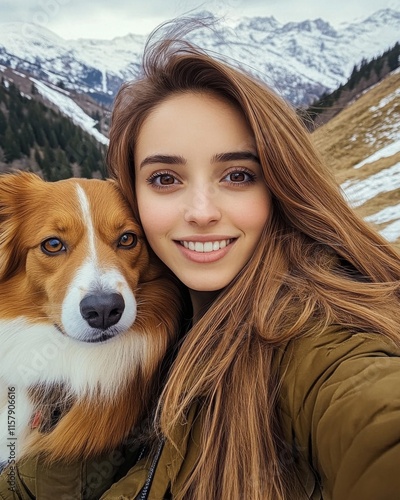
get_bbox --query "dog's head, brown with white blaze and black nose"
[0,173,155,342]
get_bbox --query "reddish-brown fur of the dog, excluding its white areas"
[0,173,180,461]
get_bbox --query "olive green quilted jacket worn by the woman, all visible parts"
[0,329,400,500]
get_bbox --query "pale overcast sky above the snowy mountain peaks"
[0,0,400,39]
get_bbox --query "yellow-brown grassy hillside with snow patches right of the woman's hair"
[312,70,400,248]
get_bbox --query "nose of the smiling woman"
[184,187,221,226]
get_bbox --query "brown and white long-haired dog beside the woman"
[0,172,180,464]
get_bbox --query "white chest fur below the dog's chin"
[0,318,147,463]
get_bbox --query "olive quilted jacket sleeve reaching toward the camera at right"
[281,331,400,500]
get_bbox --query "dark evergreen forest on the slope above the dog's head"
[0,78,106,181]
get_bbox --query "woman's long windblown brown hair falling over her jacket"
[108,18,400,500]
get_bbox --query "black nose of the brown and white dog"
[80,293,125,330]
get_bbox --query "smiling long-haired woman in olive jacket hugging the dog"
[0,21,400,500]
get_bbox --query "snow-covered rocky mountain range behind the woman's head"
[0,9,400,106]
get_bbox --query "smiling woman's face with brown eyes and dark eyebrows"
[135,93,271,292]
